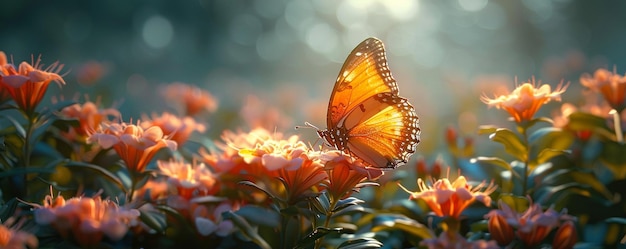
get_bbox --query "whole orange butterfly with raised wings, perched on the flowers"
[317,38,420,169]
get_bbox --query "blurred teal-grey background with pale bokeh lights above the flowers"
[0,0,626,154]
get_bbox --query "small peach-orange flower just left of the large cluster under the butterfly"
[157,161,217,200]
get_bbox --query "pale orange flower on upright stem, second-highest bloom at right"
[480,81,567,123]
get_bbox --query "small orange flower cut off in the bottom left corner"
[0,217,39,249]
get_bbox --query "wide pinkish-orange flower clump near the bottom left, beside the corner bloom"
[33,195,139,247]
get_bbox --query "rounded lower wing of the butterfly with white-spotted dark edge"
[345,93,420,169]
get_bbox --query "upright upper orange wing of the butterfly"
[326,38,398,128]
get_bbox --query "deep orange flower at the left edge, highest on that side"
[0,51,65,113]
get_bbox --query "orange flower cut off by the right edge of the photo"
[580,68,626,112]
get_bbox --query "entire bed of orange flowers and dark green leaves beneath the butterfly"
[0,48,626,249]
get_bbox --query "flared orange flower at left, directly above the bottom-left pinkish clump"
[87,123,177,172]
